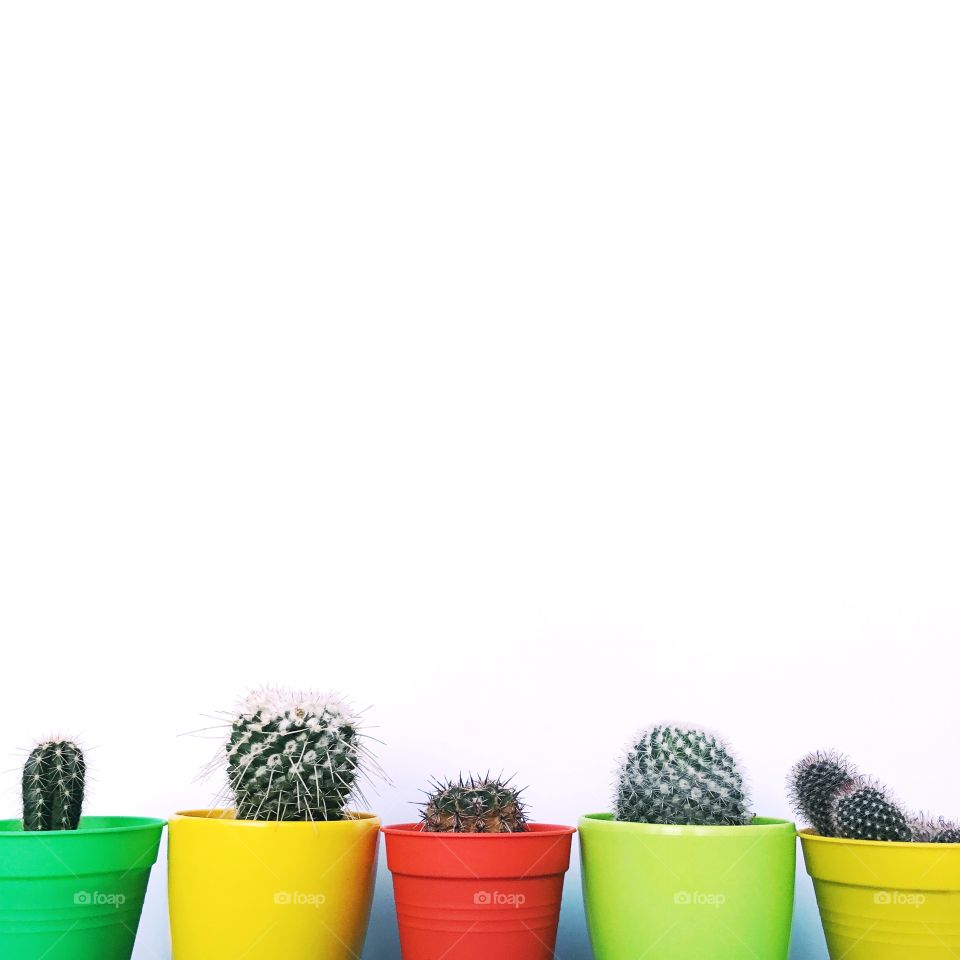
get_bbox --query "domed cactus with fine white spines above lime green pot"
[614,726,753,826]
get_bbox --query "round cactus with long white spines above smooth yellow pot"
[226,689,369,820]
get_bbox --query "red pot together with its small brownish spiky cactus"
[383,775,575,960]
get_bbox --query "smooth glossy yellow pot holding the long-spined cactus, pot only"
[169,810,380,960]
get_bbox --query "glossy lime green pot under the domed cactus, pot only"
[579,813,797,960]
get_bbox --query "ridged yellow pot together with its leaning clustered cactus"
[788,751,960,960]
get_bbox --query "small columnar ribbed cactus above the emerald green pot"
[23,740,86,831]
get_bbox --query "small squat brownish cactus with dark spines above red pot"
[421,774,527,833]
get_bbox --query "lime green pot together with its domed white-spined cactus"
[579,726,796,960]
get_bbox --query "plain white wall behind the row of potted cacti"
[0,0,960,960]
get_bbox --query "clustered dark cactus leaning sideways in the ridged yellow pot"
[787,752,960,843]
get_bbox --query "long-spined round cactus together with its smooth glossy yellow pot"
[169,689,380,960]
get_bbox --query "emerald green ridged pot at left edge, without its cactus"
[0,817,164,960]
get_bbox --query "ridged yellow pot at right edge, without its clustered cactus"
[800,830,960,960]
